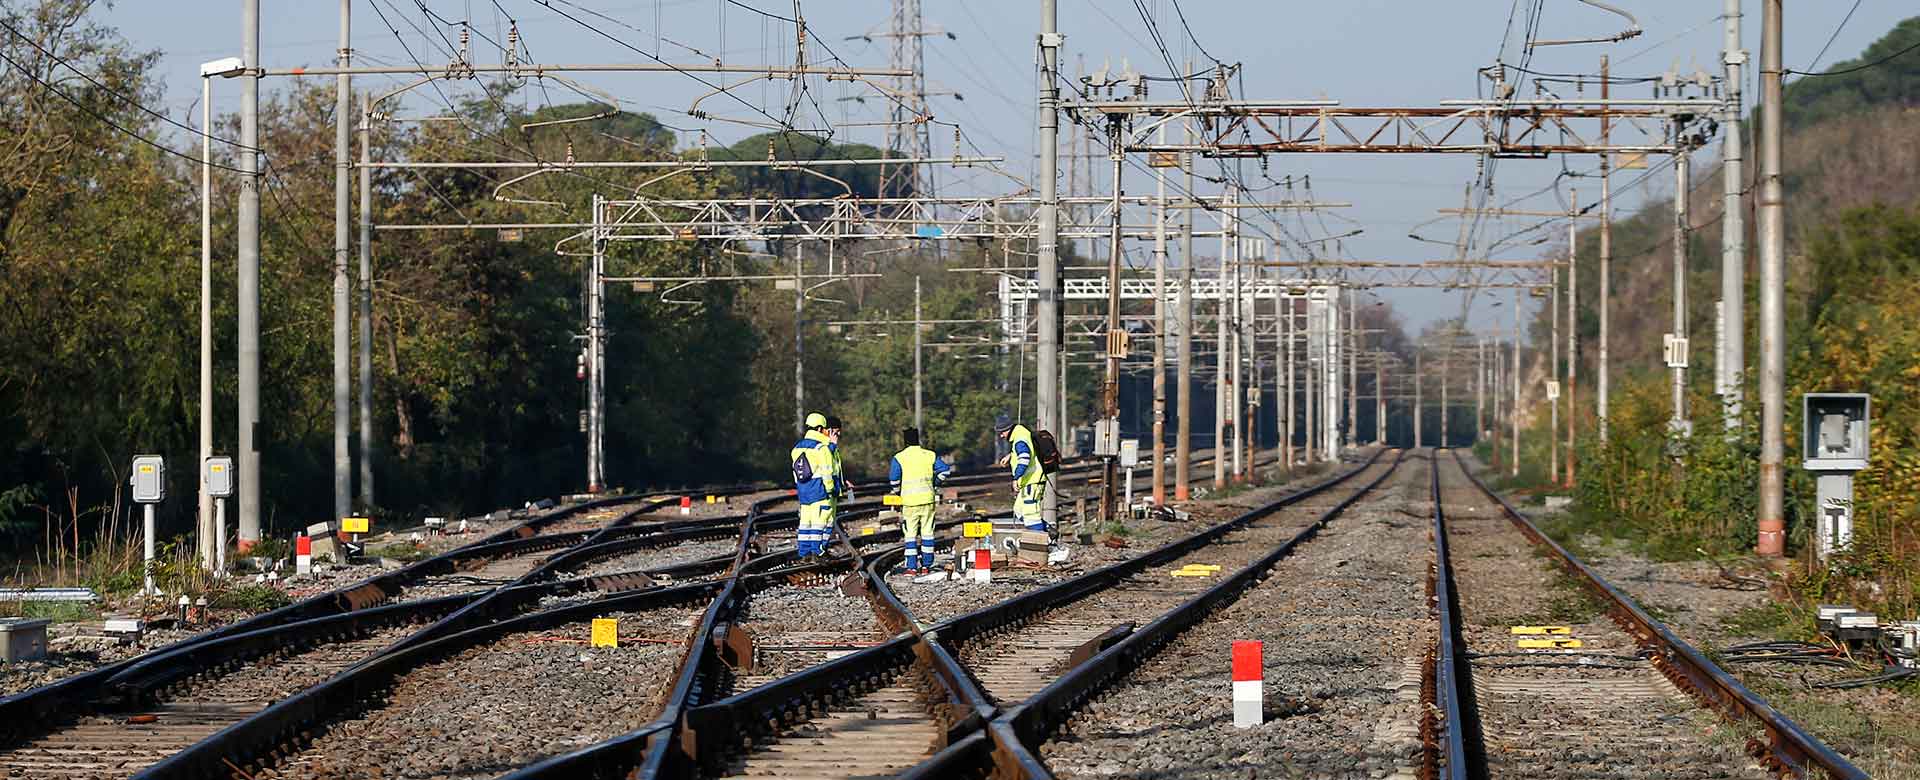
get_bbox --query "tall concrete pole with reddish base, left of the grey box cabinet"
[1753,0,1788,557]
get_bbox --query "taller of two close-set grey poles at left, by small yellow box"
[334,0,353,519]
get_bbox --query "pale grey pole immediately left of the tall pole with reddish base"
[1715,0,1747,430]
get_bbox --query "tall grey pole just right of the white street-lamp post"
[234,0,263,553]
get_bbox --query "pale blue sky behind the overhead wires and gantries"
[106,0,1916,325]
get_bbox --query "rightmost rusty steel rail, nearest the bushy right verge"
[1453,451,1868,780]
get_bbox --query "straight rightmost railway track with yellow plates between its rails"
[1428,453,1866,778]
